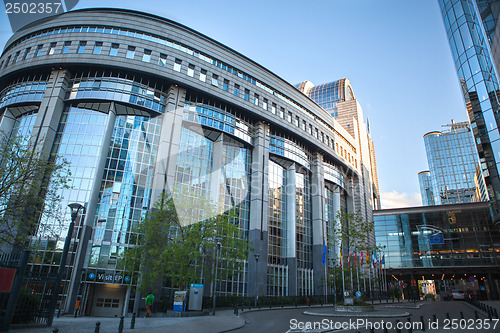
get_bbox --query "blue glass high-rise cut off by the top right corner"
[438,0,500,223]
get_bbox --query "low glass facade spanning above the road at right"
[374,203,500,268]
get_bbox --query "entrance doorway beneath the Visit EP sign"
[91,284,127,317]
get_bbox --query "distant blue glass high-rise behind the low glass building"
[418,120,488,206]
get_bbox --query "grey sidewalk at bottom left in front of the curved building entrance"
[8,310,245,333]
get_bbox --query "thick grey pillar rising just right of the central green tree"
[248,123,269,296]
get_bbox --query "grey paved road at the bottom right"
[234,301,500,333]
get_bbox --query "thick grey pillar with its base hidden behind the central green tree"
[150,86,188,201]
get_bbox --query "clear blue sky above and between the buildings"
[0,0,467,208]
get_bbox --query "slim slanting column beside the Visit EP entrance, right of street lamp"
[64,103,116,313]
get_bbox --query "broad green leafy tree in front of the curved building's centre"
[122,188,248,291]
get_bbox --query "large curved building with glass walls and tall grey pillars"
[0,9,376,315]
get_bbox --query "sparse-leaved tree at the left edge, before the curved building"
[0,133,70,252]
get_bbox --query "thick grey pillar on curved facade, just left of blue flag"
[311,153,328,295]
